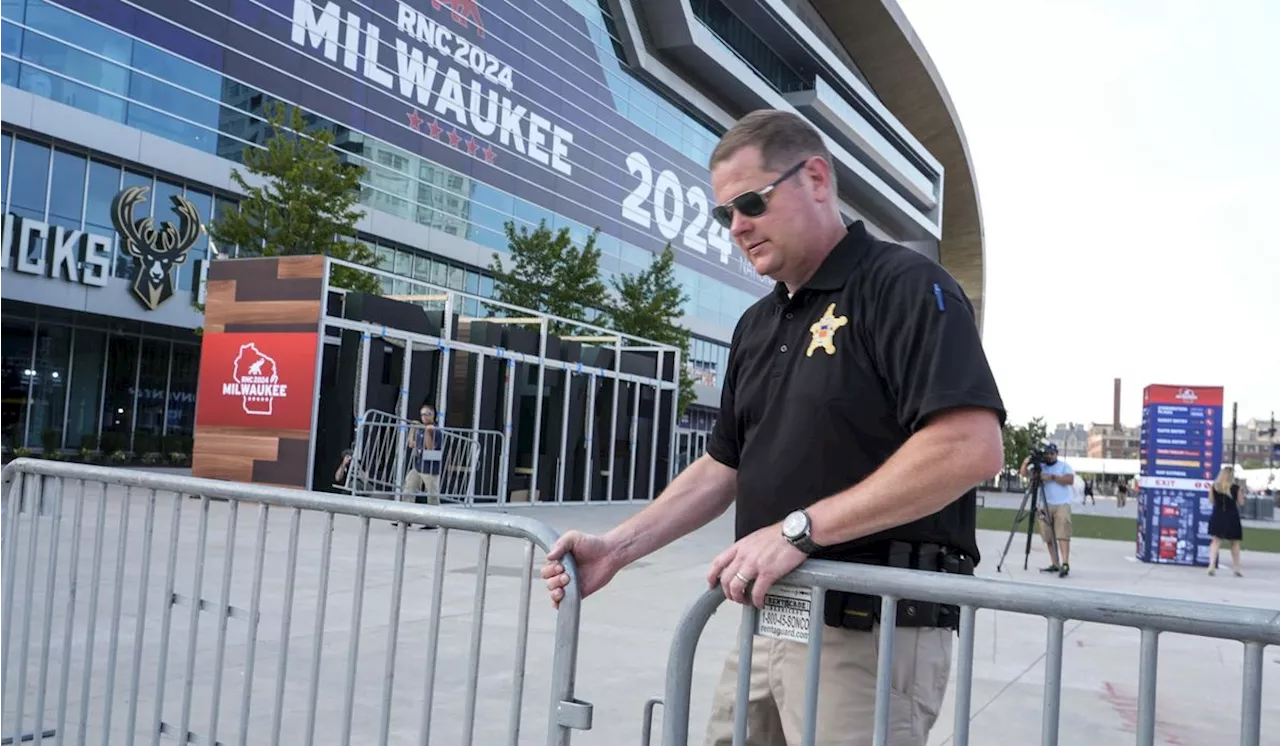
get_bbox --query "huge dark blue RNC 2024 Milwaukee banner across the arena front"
[49,0,773,294]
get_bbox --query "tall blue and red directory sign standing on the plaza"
[1137,385,1222,567]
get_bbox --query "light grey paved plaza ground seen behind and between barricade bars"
[0,478,1280,746]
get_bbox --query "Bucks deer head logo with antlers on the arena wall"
[111,187,200,311]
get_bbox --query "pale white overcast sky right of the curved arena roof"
[899,0,1280,425]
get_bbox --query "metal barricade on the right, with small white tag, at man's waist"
[641,560,1280,746]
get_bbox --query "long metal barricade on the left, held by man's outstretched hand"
[0,459,593,746]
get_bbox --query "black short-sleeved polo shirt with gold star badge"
[707,221,1005,562]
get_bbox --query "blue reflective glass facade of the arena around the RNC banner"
[0,0,747,442]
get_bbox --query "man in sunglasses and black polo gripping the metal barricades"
[541,111,1005,746]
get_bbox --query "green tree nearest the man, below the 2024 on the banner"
[609,243,695,416]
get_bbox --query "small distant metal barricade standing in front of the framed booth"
[343,409,506,505]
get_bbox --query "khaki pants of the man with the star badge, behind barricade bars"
[707,626,955,746]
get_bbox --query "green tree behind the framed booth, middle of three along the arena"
[489,220,607,334]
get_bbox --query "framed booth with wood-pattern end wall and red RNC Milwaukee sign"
[192,256,681,504]
